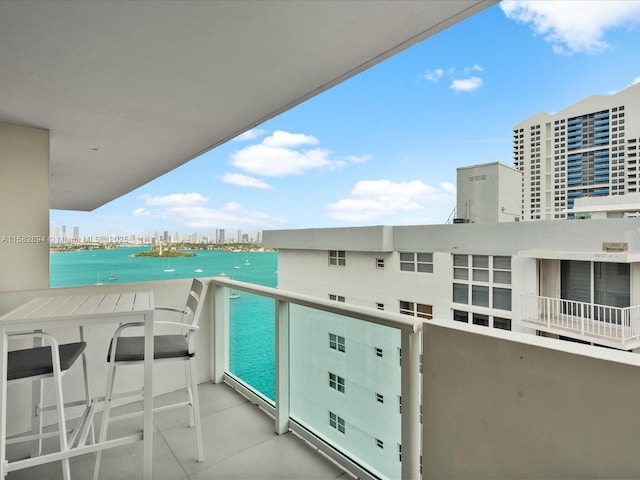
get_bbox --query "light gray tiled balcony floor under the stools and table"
[6,382,351,480]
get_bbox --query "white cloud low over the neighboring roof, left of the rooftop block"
[327,180,451,223]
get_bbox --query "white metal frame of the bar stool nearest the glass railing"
[94,279,206,480]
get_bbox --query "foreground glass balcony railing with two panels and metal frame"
[210,277,421,478]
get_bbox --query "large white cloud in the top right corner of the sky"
[500,0,640,54]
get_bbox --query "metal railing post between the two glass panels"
[276,300,290,435]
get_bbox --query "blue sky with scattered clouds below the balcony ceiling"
[51,0,640,240]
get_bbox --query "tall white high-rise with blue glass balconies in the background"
[513,84,640,220]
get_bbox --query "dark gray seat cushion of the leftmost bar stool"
[7,342,87,380]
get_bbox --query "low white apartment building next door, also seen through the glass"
[263,218,640,477]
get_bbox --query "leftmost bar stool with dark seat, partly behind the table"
[2,332,87,480]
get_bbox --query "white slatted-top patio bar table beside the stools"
[0,292,154,480]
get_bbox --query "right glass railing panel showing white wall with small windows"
[290,305,401,478]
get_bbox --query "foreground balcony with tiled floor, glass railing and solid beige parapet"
[0,277,640,480]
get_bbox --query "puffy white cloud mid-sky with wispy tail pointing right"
[231,130,372,177]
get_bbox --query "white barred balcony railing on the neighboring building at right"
[521,294,640,350]
